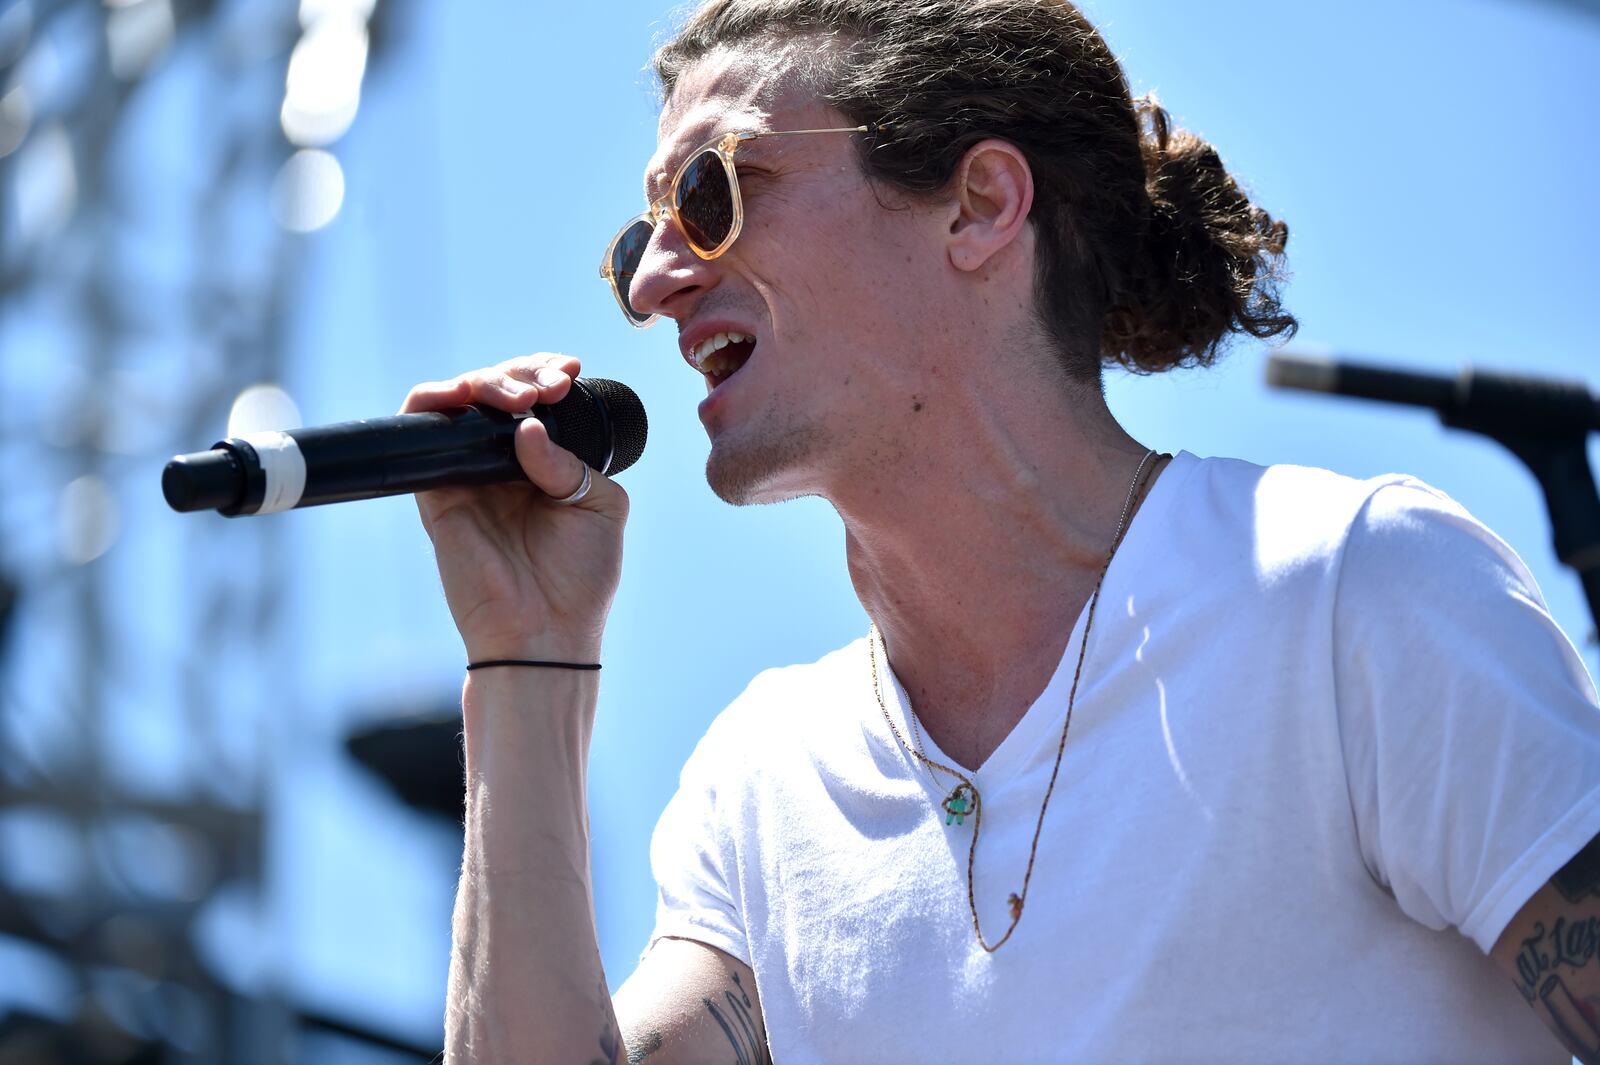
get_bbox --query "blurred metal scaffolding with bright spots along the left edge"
[0,0,427,1065]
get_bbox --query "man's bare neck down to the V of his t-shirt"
[834,369,1146,768]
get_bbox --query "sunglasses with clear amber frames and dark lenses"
[600,126,869,329]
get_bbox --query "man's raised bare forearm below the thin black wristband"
[445,667,621,1065]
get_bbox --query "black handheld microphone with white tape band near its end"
[162,377,648,518]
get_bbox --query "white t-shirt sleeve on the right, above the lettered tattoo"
[1333,483,1600,951]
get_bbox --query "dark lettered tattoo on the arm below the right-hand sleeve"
[1517,838,1600,1062]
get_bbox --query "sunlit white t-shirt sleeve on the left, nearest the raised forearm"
[645,713,750,964]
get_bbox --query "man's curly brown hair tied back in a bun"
[654,0,1296,381]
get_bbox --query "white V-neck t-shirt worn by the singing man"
[651,454,1600,1065]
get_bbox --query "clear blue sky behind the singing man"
[6,0,1600,1038]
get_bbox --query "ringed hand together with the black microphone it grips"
[162,355,646,662]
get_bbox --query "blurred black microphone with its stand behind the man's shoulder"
[1267,352,1600,627]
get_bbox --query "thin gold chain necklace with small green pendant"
[867,449,1166,955]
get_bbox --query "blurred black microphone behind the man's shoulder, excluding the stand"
[1267,352,1600,438]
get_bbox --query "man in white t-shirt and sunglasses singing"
[406,0,1600,1065]
